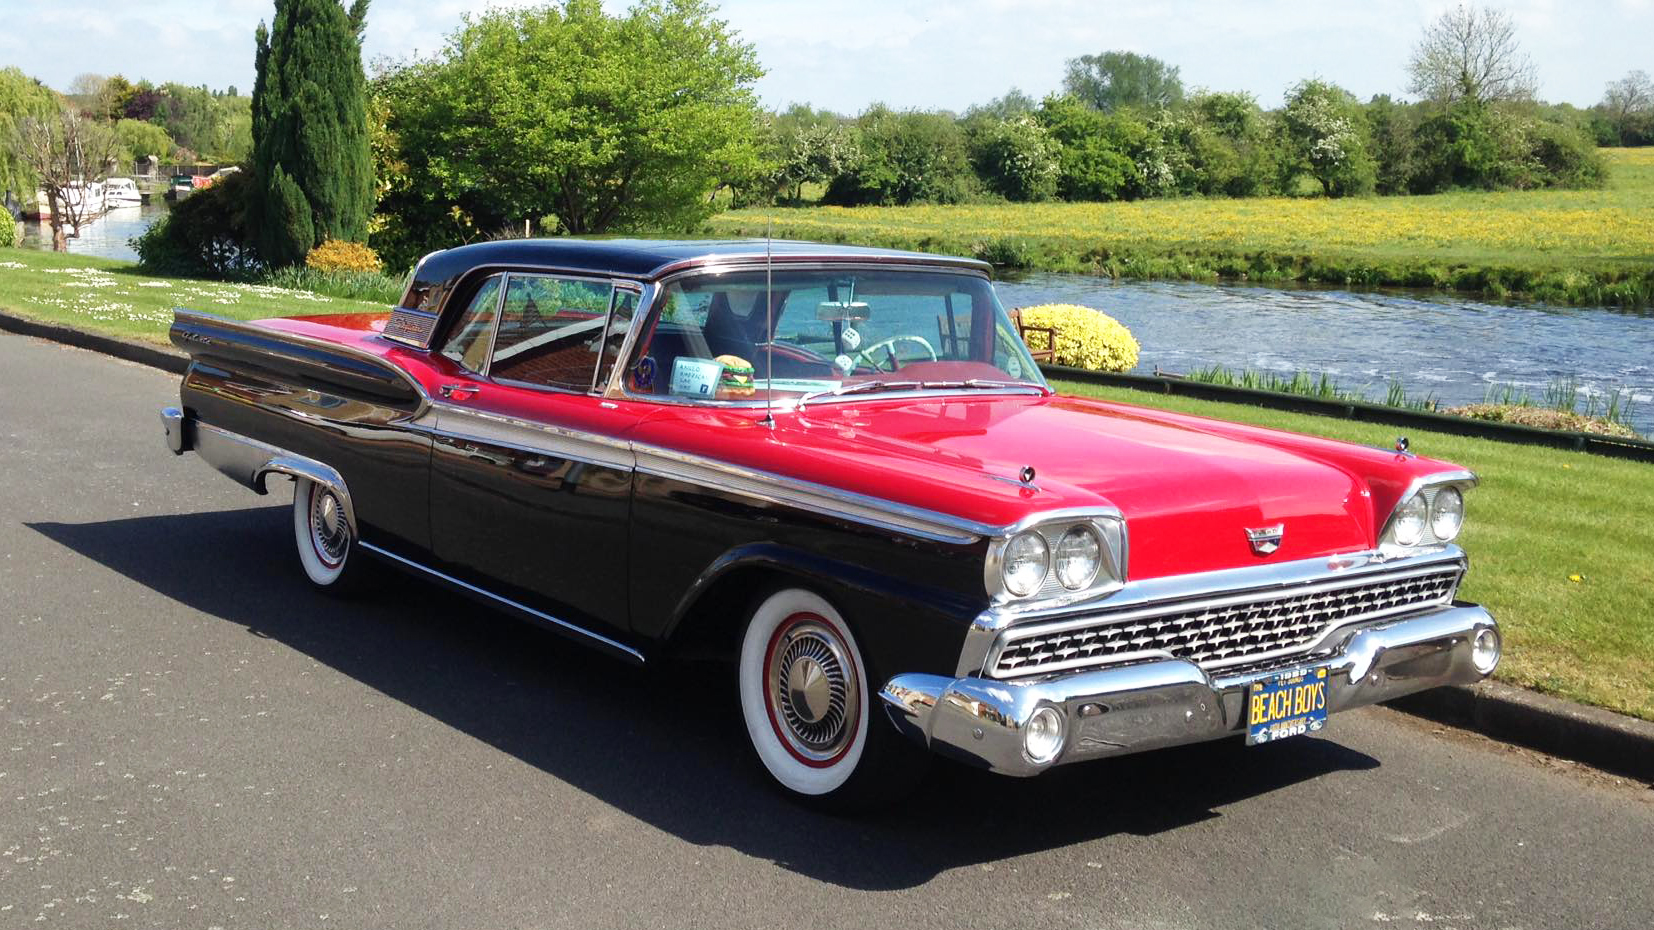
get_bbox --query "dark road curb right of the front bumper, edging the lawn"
[1388,682,1654,784]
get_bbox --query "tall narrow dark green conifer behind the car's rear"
[248,0,374,266]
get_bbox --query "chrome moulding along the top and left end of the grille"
[954,544,1469,675]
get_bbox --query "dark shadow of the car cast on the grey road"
[28,508,1378,890]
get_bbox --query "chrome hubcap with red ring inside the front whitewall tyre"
[767,617,860,761]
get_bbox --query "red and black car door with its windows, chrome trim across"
[430,273,647,637]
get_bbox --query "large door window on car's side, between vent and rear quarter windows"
[488,275,614,391]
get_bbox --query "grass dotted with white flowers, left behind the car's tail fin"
[0,248,385,343]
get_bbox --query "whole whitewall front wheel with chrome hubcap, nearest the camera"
[736,587,925,811]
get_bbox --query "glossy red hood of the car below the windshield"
[638,390,1451,579]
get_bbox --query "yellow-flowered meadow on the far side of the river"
[708,149,1654,306]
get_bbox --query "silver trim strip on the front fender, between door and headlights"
[633,445,997,544]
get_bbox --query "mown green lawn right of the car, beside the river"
[1054,382,1654,720]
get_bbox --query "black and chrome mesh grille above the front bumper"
[987,564,1464,678]
